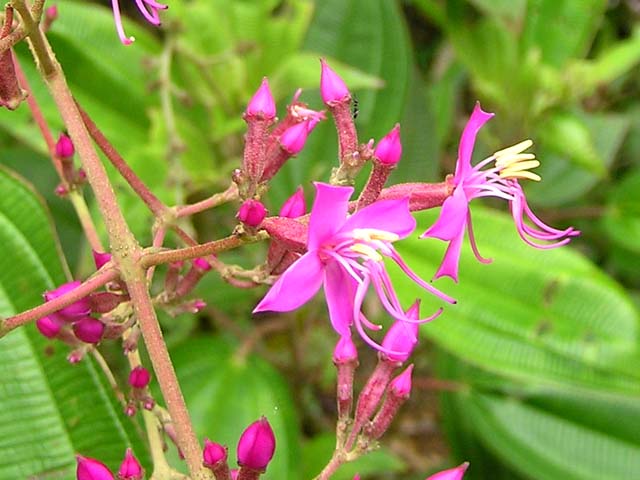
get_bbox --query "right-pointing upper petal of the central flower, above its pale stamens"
[340,197,416,238]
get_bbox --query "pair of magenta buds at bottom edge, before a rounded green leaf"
[202,417,276,480]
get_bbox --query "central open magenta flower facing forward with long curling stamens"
[254,183,454,351]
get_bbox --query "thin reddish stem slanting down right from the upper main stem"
[76,102,169,217]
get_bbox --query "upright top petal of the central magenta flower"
[307,182,353,251]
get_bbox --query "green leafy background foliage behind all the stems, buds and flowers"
[0,0,640,480]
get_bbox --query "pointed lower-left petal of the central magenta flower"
[253,252,324,313]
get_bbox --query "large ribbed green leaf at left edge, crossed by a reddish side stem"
[0,171,146,479]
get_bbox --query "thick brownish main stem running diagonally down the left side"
[12,0,212,480]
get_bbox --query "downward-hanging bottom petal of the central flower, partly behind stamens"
[324,262,359,335]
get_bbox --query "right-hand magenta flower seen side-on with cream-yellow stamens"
[421,103,580,282]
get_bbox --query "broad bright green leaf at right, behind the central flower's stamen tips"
[392,208,640,397]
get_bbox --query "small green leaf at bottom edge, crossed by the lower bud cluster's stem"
[301,434,406,480]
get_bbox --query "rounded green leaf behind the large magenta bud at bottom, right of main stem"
[171,337,300,480]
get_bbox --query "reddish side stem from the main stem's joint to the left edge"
[0,266,118,337]
